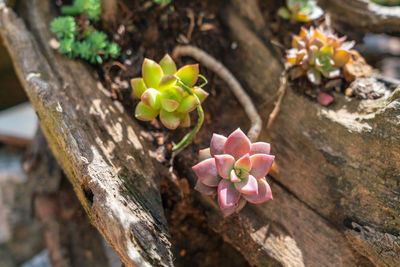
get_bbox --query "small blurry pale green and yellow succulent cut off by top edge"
[278,0,324,22]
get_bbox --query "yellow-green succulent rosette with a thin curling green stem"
[131,54,208,155]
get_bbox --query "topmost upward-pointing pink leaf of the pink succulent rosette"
[224,128,251,159]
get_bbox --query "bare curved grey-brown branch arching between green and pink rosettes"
[172,45,262,141]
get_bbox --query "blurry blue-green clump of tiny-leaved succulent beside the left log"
[50,0,120,64]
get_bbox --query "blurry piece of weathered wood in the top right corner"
[318,0,400,33]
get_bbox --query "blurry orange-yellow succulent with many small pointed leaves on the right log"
[286,27,354,84]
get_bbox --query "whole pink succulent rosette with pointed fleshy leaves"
[192,128,275,216]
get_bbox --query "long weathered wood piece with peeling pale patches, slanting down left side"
[0,0,172,266]
